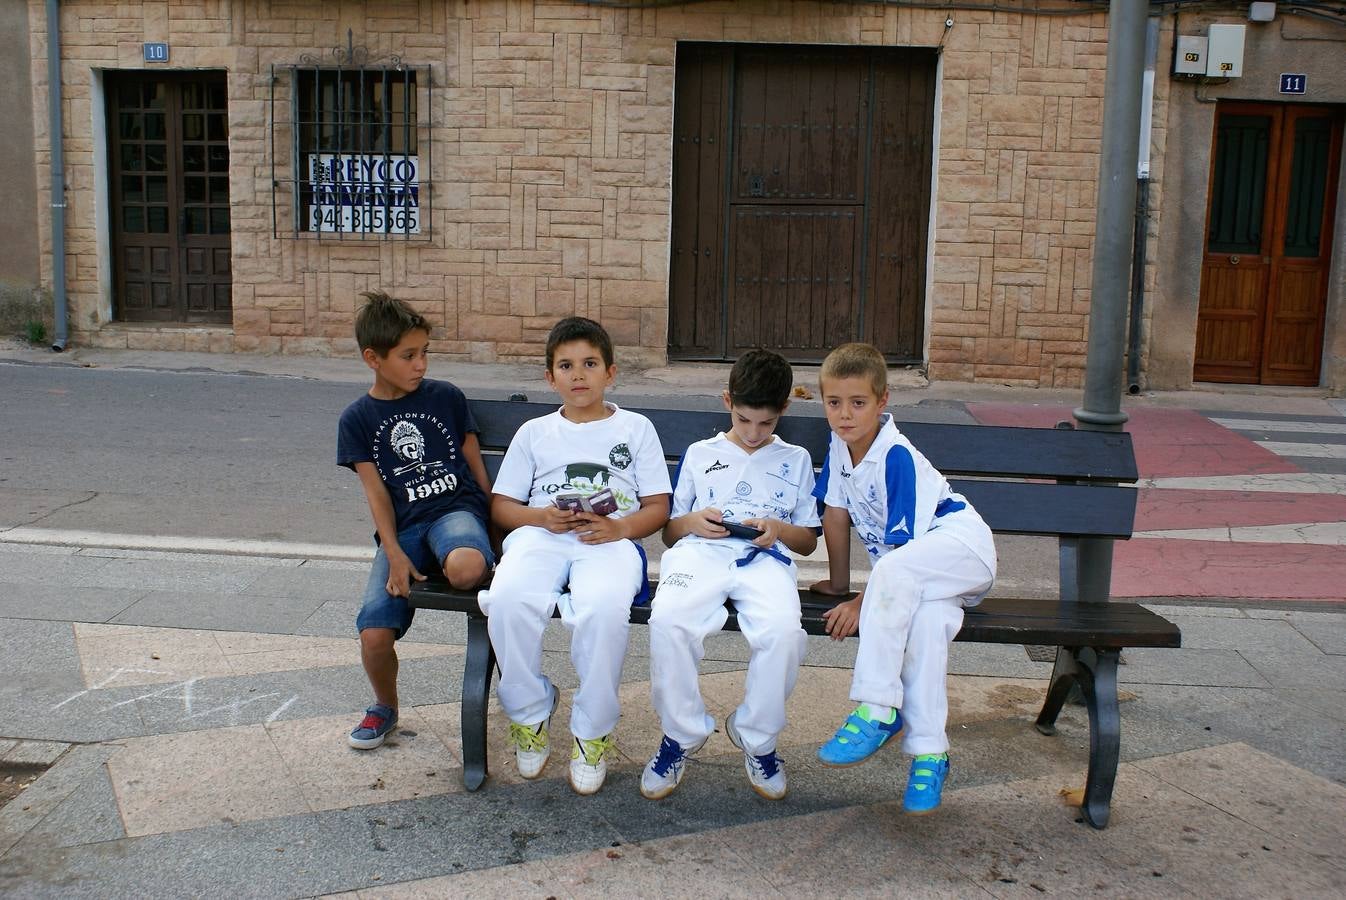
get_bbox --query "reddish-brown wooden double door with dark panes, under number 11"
[1193,102,1342,386]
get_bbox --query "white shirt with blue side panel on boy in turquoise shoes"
[813,413,995,562]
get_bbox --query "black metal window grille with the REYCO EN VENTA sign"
[271,32,433,241]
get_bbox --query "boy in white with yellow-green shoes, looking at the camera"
[478,316,672,794]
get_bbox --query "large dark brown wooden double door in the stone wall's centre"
[669,43,937,363]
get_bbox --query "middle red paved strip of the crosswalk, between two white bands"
[1135,487,1346,531]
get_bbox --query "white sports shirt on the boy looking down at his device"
[670,432,821,558]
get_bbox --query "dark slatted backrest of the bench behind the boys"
[471,400,1137,543]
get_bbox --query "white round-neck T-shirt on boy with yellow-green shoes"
[494,401,673,518]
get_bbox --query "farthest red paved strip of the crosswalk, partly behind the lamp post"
[968,404,1302,478]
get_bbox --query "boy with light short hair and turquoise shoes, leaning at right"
[813,343,996,815]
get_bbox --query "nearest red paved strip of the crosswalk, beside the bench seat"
[1112,538,1346,600]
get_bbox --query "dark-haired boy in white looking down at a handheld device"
[641,350,820,800]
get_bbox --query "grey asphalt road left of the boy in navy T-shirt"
[0,362,370,546]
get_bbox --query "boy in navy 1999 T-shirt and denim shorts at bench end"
[337,291,494,749]
